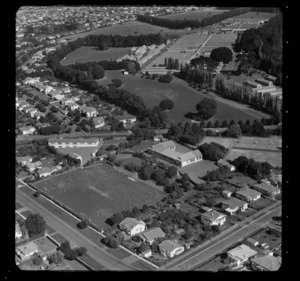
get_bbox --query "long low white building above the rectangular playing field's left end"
[48,138,99,148]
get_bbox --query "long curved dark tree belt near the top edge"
[137,8,251,29]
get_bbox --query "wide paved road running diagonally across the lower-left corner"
[16,189,136,270]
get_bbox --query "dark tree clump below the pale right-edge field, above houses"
[232,156,273,180]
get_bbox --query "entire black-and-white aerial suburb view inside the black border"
[15,4,285,273]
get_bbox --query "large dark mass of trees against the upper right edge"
[235,14,283,84]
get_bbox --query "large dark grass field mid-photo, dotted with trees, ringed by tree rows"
[98,71,268,123]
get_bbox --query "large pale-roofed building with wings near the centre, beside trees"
[149,141,202,167]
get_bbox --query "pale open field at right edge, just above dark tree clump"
[226,148,282,167]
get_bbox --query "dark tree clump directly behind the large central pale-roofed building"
[167,122,205,145]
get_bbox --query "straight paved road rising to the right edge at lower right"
[161,205,281,270]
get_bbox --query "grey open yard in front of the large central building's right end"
[179,160,218,183]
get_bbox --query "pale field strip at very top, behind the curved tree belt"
[159,8,225,21]
